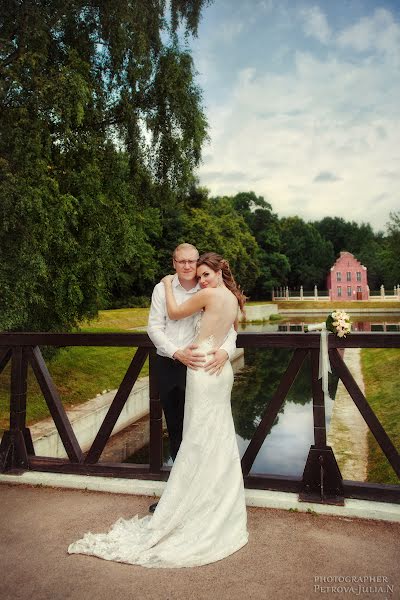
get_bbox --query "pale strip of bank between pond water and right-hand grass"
[327,348,368,481]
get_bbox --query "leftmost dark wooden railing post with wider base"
[0,346,34,472]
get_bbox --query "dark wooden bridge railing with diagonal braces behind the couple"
[0,333,400,504]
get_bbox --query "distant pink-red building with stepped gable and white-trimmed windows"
[326,252,369,302]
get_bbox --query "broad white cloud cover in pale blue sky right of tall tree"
[195,7,400,229]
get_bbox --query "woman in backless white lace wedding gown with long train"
[68,252,248,568]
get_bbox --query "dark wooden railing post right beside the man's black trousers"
[149,349,163,473]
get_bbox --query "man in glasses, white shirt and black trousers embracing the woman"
[147,244,236,512]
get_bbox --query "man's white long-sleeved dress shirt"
[147,275,237,358]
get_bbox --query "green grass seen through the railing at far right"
[361,348,400,484]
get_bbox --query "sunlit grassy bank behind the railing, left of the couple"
[0,308,149,431]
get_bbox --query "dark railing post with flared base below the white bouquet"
[299,349,344,505]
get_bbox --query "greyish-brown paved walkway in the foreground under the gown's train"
[0,484,400,600]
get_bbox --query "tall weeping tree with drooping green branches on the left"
[0,0,209,330]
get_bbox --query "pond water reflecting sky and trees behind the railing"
[127,317,400,476]
